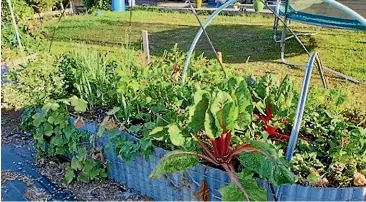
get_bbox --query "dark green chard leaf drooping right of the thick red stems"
[239,141,295,185]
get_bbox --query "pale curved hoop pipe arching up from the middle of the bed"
[182,0,237,85]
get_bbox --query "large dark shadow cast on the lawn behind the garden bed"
[149,25,314,63]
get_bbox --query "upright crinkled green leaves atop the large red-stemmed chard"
[188,78,253,138]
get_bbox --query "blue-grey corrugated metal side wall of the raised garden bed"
[70,118,366,201]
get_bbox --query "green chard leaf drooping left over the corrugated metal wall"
[150,151,199,178]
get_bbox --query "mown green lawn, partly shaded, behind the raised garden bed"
[44,11,366,108]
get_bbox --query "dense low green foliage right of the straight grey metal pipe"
[291,103,366,186]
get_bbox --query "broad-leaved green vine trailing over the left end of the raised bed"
[22,97,107,183]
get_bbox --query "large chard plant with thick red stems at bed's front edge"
[151,78,294,200]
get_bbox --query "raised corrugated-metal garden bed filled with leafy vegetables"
[4,47,366,201]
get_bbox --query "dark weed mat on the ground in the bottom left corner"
[1,144,77,201]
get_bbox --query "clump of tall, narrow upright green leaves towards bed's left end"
[58,51,119,107]
